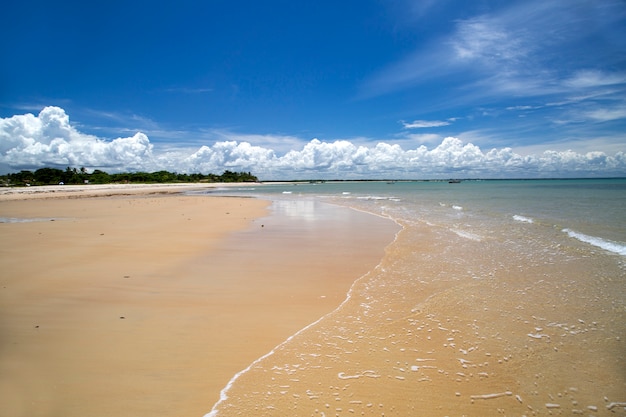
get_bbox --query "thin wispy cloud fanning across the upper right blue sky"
[362,0,625,101]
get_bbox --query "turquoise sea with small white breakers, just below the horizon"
[208,179,626,255]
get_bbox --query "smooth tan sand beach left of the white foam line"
[0,188,397,416]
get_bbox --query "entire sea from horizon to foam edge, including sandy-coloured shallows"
[202,179,626,416]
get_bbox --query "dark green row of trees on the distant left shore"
[0,167,258,186]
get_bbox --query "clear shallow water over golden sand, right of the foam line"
[211,214,626,417]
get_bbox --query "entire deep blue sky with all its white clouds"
[0,0,626,180]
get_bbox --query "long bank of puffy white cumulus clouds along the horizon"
[0,107,626,180]
